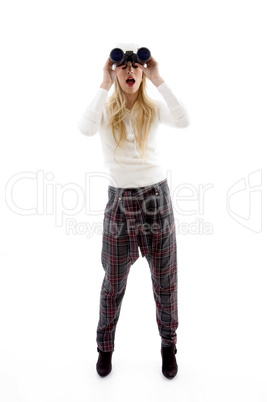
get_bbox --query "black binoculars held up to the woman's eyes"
[109,47,151,68]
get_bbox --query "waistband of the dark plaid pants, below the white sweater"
[108,179,169,197]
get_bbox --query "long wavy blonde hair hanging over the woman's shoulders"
[106,73,158,162]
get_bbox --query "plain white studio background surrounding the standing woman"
[0,0,267,402]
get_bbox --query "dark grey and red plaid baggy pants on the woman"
[96,179,178,352]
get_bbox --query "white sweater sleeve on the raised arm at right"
[157,81,190,128]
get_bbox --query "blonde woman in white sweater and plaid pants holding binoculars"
[79,44,189,379]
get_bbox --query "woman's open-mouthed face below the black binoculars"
[117,61,143,95]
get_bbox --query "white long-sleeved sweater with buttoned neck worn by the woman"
[78,82,189,188]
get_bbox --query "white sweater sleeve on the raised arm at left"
[78,88,108,136]
